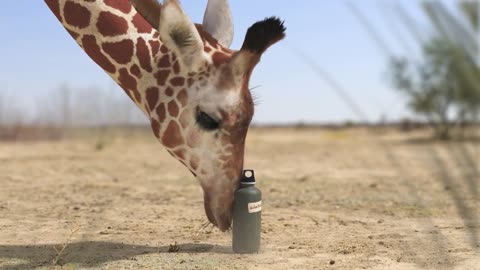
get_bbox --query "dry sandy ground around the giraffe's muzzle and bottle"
[0,129,480,270]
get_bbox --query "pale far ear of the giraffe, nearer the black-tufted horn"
[203,0,233,48]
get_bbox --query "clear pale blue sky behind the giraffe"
[0,0,458,123]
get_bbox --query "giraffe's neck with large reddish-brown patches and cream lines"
[46,0,174,114]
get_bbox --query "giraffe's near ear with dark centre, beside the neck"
[158,0,203,68]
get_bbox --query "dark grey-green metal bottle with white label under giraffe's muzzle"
[232,170,262,254]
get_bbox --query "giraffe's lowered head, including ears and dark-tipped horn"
[128,0,285,230]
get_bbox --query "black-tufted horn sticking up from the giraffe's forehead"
[231,17,286,77]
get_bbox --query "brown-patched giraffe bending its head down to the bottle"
[45,0,285,231]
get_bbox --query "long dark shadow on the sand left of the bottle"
[0,241,232,270]
